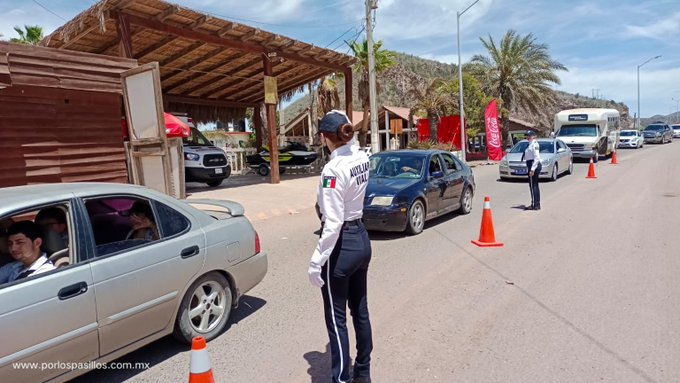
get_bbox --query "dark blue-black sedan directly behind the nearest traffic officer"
[364,150,475,234]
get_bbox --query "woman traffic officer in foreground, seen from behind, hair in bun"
[309,110,373,383]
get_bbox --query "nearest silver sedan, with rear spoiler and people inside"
[0,183,267,382]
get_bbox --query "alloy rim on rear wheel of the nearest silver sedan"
[189,281,226,333]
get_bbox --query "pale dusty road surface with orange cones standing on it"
[76,142,680,383]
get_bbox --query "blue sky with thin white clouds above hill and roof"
[0,0,680,117]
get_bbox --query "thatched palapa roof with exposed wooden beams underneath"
[43,0,355,121]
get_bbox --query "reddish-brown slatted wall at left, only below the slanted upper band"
[0,86,128,187]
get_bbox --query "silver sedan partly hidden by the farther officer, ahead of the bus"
[498,138,574,181]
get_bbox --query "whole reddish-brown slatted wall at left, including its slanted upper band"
[0,42,137,187]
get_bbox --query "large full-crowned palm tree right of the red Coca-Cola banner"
[470,30,567,142]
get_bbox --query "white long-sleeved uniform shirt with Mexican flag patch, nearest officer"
[311,142,370,266]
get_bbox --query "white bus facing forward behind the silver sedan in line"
[554,108,621,162]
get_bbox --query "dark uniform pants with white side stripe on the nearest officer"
[321,220,373,383]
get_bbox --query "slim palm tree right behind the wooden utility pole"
[345,40,394,147]
